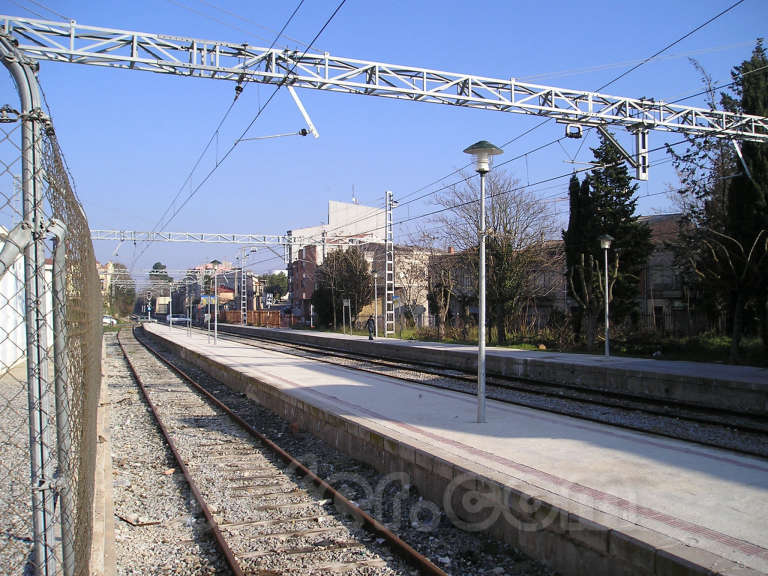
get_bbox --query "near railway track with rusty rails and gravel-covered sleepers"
[118,331,445,576]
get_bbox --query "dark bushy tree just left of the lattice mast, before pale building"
[312,246,373,329]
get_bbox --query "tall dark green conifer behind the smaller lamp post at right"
[563,136,653,349]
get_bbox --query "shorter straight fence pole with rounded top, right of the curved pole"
[49,220,75,576]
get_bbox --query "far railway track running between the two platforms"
[202,326,768,457]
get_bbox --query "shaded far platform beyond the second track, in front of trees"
[216,325,768,417]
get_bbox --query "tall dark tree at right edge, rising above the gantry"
[668,44,768,362]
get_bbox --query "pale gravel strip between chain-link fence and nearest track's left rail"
[103,332,229,575]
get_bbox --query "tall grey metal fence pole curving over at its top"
[0,33,56,576]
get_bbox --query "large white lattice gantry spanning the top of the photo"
[0,16,768,180]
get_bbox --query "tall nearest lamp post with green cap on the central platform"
[464,140,504,423]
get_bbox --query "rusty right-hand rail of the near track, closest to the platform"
[130,329,448,576]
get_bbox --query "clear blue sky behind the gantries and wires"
[0,0,768,280]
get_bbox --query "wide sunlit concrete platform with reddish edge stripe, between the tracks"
[145,325,768,576]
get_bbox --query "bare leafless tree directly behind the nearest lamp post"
[438,170,557,344]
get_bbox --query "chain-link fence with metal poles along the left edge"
[0,34,102,576]
